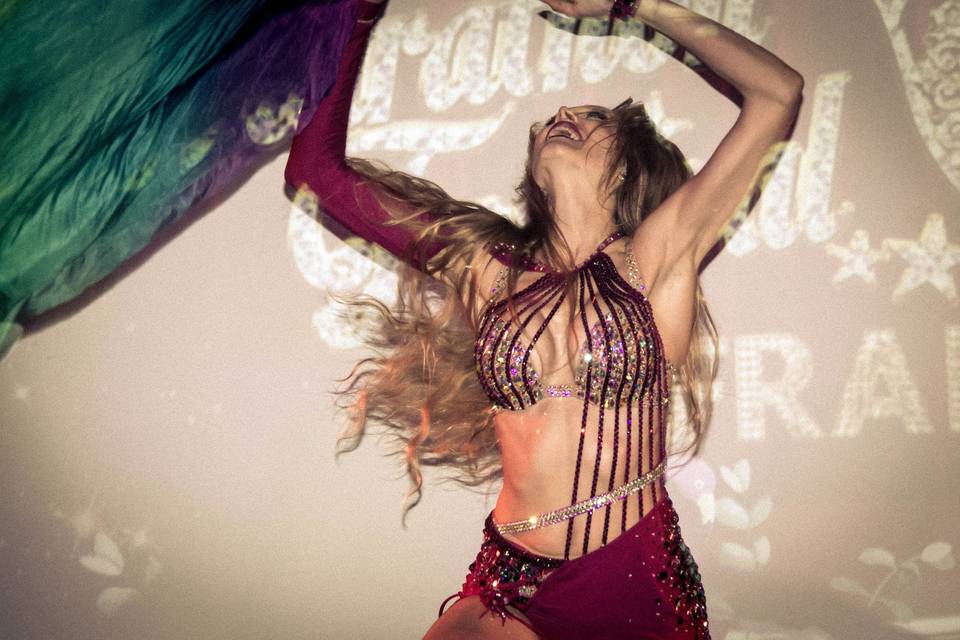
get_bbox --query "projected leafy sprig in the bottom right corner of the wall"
[830,542,960,624]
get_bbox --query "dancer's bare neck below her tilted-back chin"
[547,180,617,266]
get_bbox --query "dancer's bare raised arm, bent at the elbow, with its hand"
[544,0,803,269]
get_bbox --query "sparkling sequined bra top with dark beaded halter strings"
[474,233,660,411]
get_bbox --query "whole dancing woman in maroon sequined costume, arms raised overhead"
[286,0,803,640]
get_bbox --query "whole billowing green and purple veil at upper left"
[0,0,356,358]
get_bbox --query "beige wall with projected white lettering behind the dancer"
[0,0,960,640]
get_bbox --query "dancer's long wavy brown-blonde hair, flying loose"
[334,101,718,518]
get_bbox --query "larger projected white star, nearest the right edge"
[884,213,960,304]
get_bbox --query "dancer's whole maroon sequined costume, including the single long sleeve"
[286,2,710,639]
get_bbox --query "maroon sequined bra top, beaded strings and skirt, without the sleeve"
[441,234,710,638]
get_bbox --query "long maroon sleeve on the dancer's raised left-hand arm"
[284,0,442,267]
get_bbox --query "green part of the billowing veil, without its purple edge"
[0,0,263,355]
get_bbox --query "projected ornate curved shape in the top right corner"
[874,0,960,189]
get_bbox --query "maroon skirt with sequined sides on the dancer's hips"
[440,496,710,640]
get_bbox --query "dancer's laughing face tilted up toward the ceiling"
[531,105,615,190]
